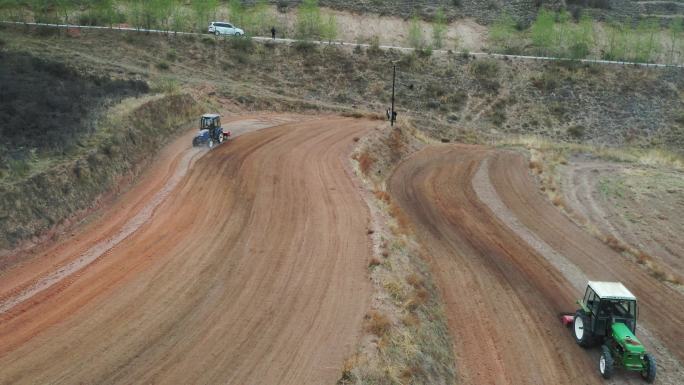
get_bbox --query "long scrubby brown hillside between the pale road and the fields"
[5,24,684,150]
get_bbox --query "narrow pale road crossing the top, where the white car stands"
[0,21,684,68]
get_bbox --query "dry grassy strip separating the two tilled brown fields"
[338,123,456,385]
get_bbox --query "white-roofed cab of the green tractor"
[578,281,637,337]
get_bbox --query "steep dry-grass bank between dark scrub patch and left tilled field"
[0,94,199,254]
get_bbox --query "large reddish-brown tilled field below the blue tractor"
[0,118,372,384]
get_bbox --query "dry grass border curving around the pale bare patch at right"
[497,137,684,292]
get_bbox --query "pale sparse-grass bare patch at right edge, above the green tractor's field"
[562,157,684,277]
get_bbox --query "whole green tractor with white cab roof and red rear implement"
[563,281,656,383]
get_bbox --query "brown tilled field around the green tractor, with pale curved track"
[390,145,684,384]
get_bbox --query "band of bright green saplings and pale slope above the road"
[0,0,684,64]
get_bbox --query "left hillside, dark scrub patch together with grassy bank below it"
[0,43,197,250]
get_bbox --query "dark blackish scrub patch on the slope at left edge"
[0,51,148,179]
